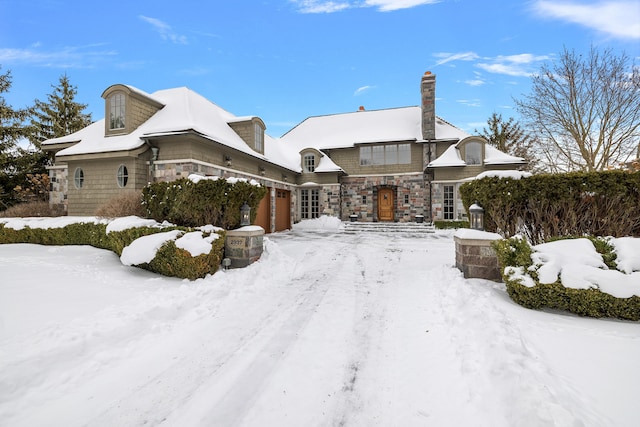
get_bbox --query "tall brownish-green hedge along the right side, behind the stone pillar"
[460,171,640,244]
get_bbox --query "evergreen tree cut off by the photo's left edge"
[0,67,28,210]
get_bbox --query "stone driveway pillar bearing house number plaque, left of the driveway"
[224,225,264,268]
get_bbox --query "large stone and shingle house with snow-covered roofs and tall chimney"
[42,72,525,232]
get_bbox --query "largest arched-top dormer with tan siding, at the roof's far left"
[102,84,164,136]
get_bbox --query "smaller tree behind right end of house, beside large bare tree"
[475,113,538,170]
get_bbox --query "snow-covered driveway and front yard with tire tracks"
[0,220,640,427]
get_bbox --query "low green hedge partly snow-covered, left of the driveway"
[0,223,224,280]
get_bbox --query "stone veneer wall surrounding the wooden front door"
[340,173,429,222]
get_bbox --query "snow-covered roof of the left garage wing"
[43,87,299,170]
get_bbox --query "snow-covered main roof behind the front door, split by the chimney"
[280,107,470,150]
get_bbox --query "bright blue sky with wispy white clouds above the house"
[0,0,640,137]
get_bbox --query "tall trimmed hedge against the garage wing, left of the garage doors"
[142,178,267,230]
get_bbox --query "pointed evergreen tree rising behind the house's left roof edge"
[29,74,91,148]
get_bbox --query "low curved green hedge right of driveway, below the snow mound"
[492,237,640,320]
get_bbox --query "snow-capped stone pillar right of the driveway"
[453,229,502,282]
